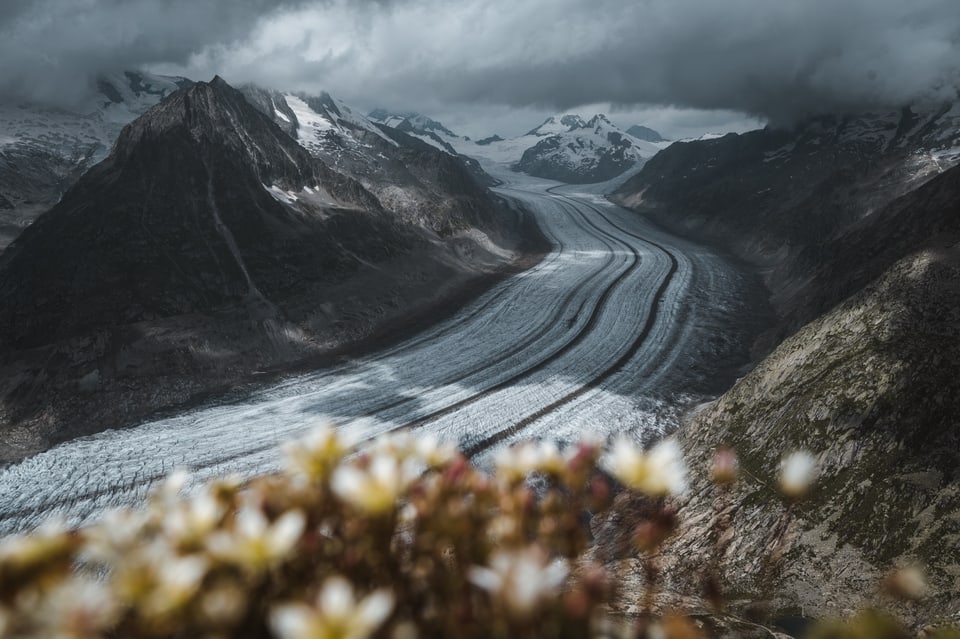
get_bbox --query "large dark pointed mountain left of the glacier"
[0,78,518,460]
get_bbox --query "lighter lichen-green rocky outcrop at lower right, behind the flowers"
[663,235,960,623]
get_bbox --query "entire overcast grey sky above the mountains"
[0,0,960,137]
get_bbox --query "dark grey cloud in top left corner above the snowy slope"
[0,0,303,103]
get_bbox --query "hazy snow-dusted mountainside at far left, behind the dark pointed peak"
[0,71,190,251]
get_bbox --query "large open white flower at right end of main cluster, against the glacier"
[606,437,687,497]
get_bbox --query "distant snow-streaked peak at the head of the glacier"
[515,115,660,184]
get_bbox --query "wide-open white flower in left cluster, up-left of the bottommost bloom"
[207,506,307,568]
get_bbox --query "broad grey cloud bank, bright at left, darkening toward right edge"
[174,0,960,124]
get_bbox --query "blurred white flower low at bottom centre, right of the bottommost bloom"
[469,546,568,617]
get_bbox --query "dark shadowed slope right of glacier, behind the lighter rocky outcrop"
[612,105,960,343]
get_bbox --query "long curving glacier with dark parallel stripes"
[0,171,764,534]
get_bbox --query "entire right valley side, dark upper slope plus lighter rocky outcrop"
[614,106,960,623]
